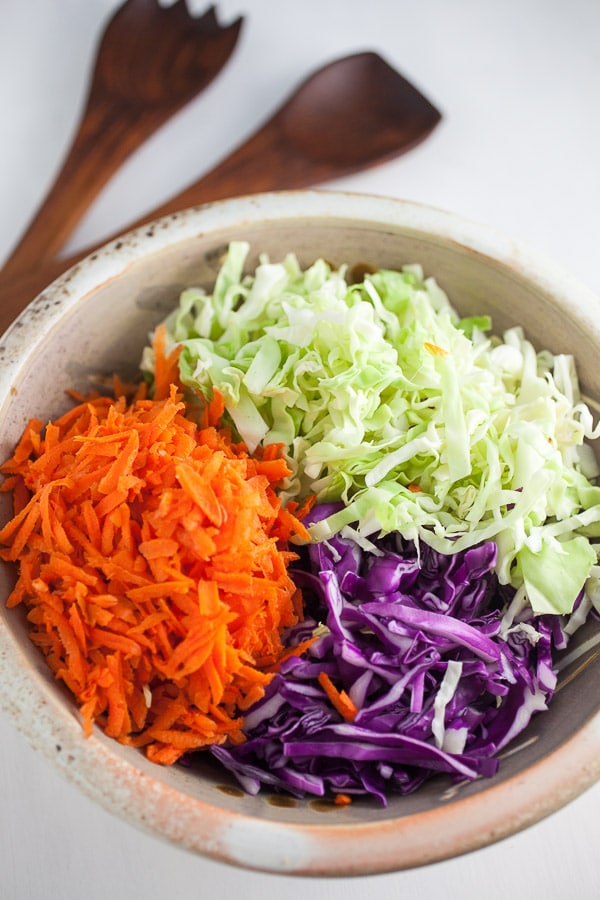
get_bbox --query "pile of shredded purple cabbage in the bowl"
[211,505,565,805]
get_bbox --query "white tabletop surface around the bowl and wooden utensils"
[0,0,600,900]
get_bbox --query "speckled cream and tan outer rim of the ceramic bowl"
[0,191,600,876]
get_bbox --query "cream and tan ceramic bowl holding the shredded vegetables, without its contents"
[0,192,600,876]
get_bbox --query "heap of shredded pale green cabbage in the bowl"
[142,242,600,614]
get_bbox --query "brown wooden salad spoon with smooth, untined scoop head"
[0,52,441,333]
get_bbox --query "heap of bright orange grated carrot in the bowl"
[0,376,306,764]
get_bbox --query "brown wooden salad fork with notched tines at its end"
[3,0,242,273]
